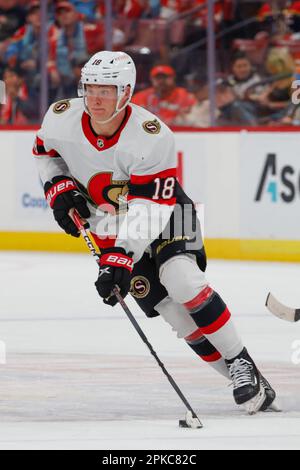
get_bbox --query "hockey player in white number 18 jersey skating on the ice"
[34,51,275,414]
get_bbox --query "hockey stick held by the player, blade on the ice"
[70,211,203,428]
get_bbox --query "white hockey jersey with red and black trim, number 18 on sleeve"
[33,98,177,261]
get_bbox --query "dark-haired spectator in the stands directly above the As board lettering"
[227,52,262,100]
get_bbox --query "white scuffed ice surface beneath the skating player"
[0,252,300,450]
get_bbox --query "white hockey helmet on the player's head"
[78,51,136,124]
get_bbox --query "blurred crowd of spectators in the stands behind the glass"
[0,0,300,127]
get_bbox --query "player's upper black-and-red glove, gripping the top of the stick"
[44,176,91,237]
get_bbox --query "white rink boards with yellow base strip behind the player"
[0,129,300,261]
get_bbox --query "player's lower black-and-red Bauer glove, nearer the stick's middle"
[95,248,133,306]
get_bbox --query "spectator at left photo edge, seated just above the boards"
[0,67,38,125]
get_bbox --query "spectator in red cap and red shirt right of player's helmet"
[132,65,196,125]
